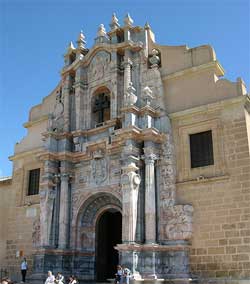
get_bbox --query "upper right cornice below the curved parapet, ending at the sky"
[161,60,225,80]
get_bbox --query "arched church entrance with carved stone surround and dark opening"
[74,192,122,281]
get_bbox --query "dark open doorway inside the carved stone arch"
[96,210,122,281]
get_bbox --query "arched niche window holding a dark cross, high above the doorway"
[92,90,110,127]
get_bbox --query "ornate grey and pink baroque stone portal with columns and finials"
[33,13,193,283]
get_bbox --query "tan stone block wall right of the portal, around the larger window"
[171,98,250,279]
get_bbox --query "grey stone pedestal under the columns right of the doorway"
[116,241,192,284]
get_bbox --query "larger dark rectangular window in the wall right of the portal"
[189,130,214,168]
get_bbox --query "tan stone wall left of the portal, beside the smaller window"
[0,154,40,280]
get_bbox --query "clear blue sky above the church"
[0,0,250,176]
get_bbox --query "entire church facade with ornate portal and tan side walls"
[0,15,250,284]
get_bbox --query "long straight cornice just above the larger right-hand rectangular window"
[169,96,247,119]
